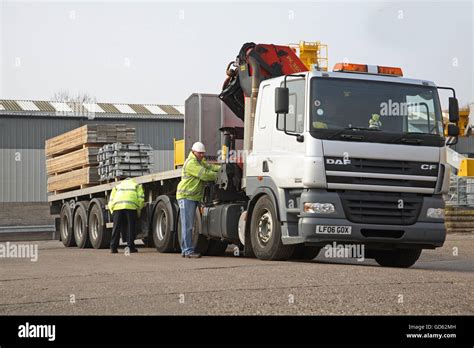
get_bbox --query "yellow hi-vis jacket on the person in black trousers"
[108,179,145,214]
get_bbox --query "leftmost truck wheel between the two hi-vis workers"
[152,201,175,253]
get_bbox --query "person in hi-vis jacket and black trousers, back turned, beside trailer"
[108,178,145,254]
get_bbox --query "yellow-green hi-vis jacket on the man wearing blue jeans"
[176,152,220,202]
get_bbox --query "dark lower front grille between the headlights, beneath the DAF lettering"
[339,191,423,225]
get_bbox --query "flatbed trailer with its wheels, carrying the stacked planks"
[48,169,181,252]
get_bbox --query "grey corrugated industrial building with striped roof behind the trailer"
[0,100,184,203]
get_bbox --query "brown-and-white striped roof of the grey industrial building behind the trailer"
[0,99,184,119]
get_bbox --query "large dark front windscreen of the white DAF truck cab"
[310,78,442,138]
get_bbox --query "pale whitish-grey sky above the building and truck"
[0,0,474,104]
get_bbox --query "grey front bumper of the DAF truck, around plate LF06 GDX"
[283,189,446,249]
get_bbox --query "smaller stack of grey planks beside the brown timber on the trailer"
[97,143,153,181]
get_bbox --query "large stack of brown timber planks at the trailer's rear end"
[45,124,136,194]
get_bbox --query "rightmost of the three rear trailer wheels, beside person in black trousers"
[87,199,112,249]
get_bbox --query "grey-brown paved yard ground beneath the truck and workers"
[0,234,474,315]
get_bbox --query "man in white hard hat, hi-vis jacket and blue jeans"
[176,142,220,258]
